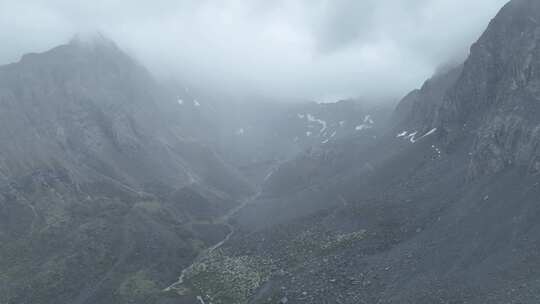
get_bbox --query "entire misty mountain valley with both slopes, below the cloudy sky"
[0,0,540,304]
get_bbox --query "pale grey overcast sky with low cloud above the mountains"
[0,0,506,100]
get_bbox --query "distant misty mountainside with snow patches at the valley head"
[162,84,392,184]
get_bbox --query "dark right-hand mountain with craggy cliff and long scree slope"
[166,0,540,304]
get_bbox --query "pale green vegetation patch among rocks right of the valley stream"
[179,230,367,304]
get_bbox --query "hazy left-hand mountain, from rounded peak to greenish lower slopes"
[0,37,254,303]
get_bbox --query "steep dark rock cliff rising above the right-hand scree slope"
[432,0,540,176]
